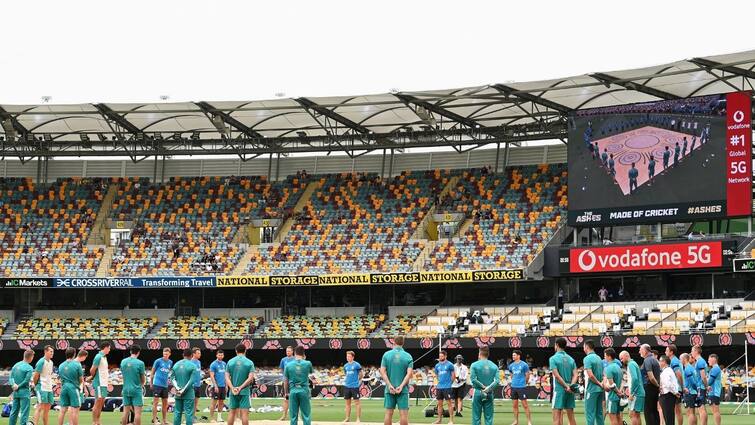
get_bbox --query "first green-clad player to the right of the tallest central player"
[469,346,500,425]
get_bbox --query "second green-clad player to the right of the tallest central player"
[548,338,579,425]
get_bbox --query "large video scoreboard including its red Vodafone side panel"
[568,92,752,227]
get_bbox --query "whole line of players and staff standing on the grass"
[9,336,722,425]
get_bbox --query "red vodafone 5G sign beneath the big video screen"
[561,241,724,273]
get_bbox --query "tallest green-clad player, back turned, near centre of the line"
[380,335,414,425]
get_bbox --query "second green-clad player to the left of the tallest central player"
[225,344,254,425]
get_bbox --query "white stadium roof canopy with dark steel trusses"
[0,50,755,161]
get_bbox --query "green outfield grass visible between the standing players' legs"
[8,398,755,425]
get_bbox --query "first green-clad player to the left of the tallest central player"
[283,345,314,425]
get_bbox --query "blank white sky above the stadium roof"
[0,0,755,104]
